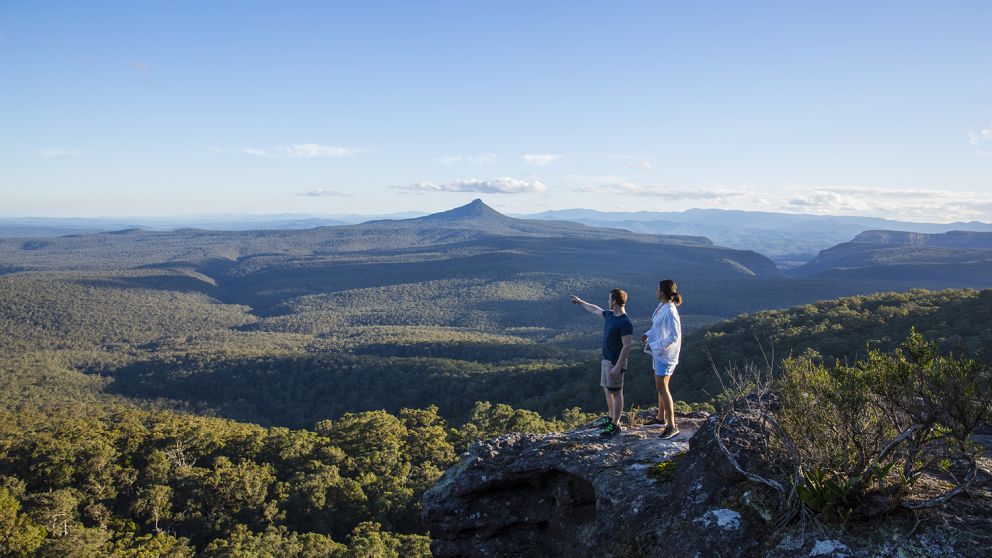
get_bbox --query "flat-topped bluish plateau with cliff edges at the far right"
[791,231,992,287]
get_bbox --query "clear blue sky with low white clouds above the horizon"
[0,0,992,221]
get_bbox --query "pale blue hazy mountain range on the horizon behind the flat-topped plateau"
[532,209,992,267]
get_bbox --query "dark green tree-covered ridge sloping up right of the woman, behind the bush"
[672,289,992,400]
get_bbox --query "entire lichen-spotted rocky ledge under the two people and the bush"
[424,413,992,558]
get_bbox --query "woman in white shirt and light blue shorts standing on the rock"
[641,279,682,439]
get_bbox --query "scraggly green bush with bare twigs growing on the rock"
[775,331,992,521]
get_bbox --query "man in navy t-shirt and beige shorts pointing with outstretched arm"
[572,289,634,436]
